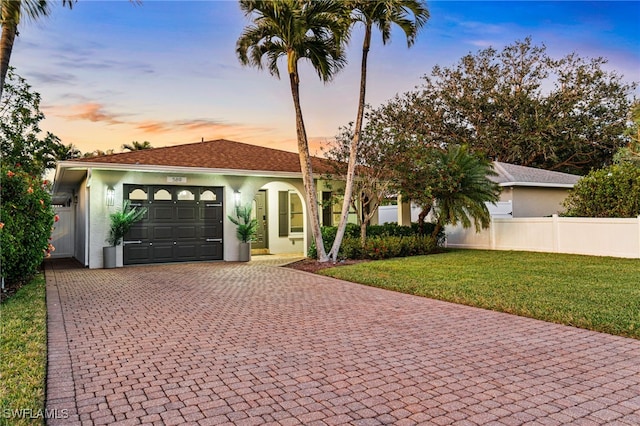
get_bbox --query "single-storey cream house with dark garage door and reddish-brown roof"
[53,139,356,268]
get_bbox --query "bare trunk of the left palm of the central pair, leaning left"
[289,72,329,262]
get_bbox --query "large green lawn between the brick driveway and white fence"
[321,250,640,339]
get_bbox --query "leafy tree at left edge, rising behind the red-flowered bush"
[0,69,63,176]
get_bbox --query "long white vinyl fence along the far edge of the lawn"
[446,215,640,258]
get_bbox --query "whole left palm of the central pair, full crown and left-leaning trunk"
[236,0,348,261]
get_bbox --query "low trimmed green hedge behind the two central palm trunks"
[307,223,442,260]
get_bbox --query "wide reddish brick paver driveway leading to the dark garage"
[47,263,640,425]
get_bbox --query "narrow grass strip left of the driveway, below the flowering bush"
[0,274,47,425]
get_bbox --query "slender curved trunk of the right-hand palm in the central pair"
[329,22,372,262]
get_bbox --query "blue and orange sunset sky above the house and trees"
[11,0,640,156]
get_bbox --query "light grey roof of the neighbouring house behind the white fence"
[490,161,581,188]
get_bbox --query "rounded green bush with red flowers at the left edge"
[0,165,57,286]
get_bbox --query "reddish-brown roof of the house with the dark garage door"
[74,139,332,173]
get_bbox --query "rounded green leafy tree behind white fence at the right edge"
[564,162,640,217]
